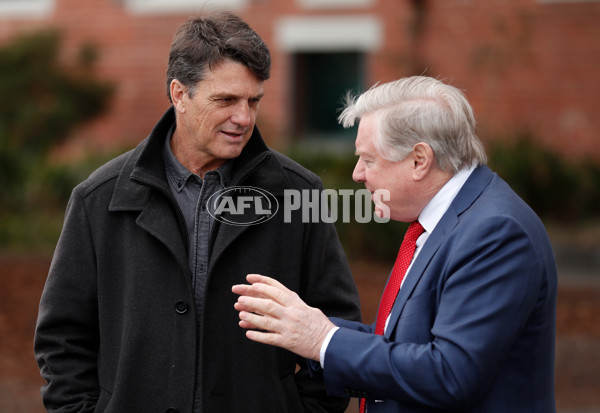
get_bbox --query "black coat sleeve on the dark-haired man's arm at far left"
[34,189,99,412]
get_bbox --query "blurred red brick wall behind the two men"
[0,0,600,159]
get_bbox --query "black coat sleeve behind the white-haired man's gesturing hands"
[296,198,361,412]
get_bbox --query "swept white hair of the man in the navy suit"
[338,76,487,174]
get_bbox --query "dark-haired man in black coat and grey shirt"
[35,13,360,413]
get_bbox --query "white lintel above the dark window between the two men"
[275,16,383,53]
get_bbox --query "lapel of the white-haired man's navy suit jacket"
[385,165,495,338]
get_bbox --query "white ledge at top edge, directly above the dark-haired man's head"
[122,0,249,14]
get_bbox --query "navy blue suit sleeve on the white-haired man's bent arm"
[324,217,546,410]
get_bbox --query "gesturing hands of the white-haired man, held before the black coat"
[231,274,335,361]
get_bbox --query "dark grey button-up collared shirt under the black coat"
[163,128,231,412]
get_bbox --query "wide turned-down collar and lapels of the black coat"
[109,107,291,271]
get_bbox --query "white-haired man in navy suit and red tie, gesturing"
[233,76,557,413]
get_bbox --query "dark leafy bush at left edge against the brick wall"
[0,29,114,213]
